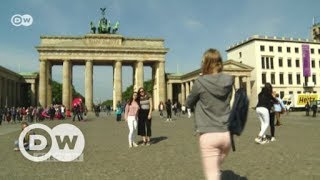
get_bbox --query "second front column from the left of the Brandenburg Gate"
[62,60,71,110]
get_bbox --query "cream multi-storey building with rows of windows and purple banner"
[226,35,320,106]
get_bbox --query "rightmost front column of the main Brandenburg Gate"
[157,61,167,106]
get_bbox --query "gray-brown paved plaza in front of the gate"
[0,110,320,180]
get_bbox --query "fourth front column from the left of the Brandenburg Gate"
[113,61,122,110]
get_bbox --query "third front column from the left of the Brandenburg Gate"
[85,60,93,111]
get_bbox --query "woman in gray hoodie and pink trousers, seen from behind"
[187,49,234,180]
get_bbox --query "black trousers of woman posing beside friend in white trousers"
[138,109,151,137]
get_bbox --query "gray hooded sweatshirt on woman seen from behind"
[187,73,234,133]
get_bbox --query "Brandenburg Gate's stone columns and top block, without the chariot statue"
[36,34,168,111]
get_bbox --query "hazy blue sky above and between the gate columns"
[0,0,320,102]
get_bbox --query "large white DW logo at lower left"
[19,124,85,162]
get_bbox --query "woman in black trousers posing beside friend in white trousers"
[138,88,152,145]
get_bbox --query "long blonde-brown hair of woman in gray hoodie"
[201,48,223,75]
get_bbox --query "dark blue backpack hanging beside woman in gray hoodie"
[229,87,249,151]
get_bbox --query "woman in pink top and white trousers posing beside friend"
[124,92,140,148]
